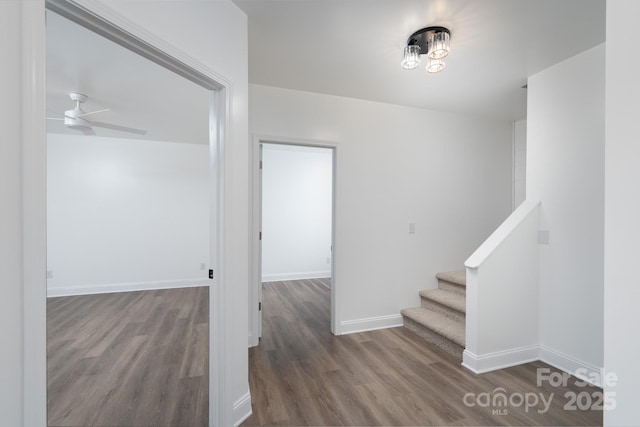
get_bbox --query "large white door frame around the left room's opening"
[22,0,233,426]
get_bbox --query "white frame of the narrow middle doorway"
[249,134,341,347]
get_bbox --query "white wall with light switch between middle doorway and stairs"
[250,85,512,333]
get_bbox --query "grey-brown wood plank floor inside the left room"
[47,287,209,427]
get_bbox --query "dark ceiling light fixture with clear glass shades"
[400,27,451,73]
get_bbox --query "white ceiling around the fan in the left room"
[47,12,209,144]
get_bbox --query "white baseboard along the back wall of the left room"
[47,279,210,298]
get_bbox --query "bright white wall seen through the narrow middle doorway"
[262,144,333,282]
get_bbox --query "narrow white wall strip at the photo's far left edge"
[0,0,24,426]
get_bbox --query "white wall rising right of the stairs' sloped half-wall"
[527,45,605,371]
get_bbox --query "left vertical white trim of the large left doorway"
[22,0,47,426]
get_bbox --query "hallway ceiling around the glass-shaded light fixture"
[233,0,605,121]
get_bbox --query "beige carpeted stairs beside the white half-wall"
[401,271,467,360]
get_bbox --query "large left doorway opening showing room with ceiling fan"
[46,7,210,426]
